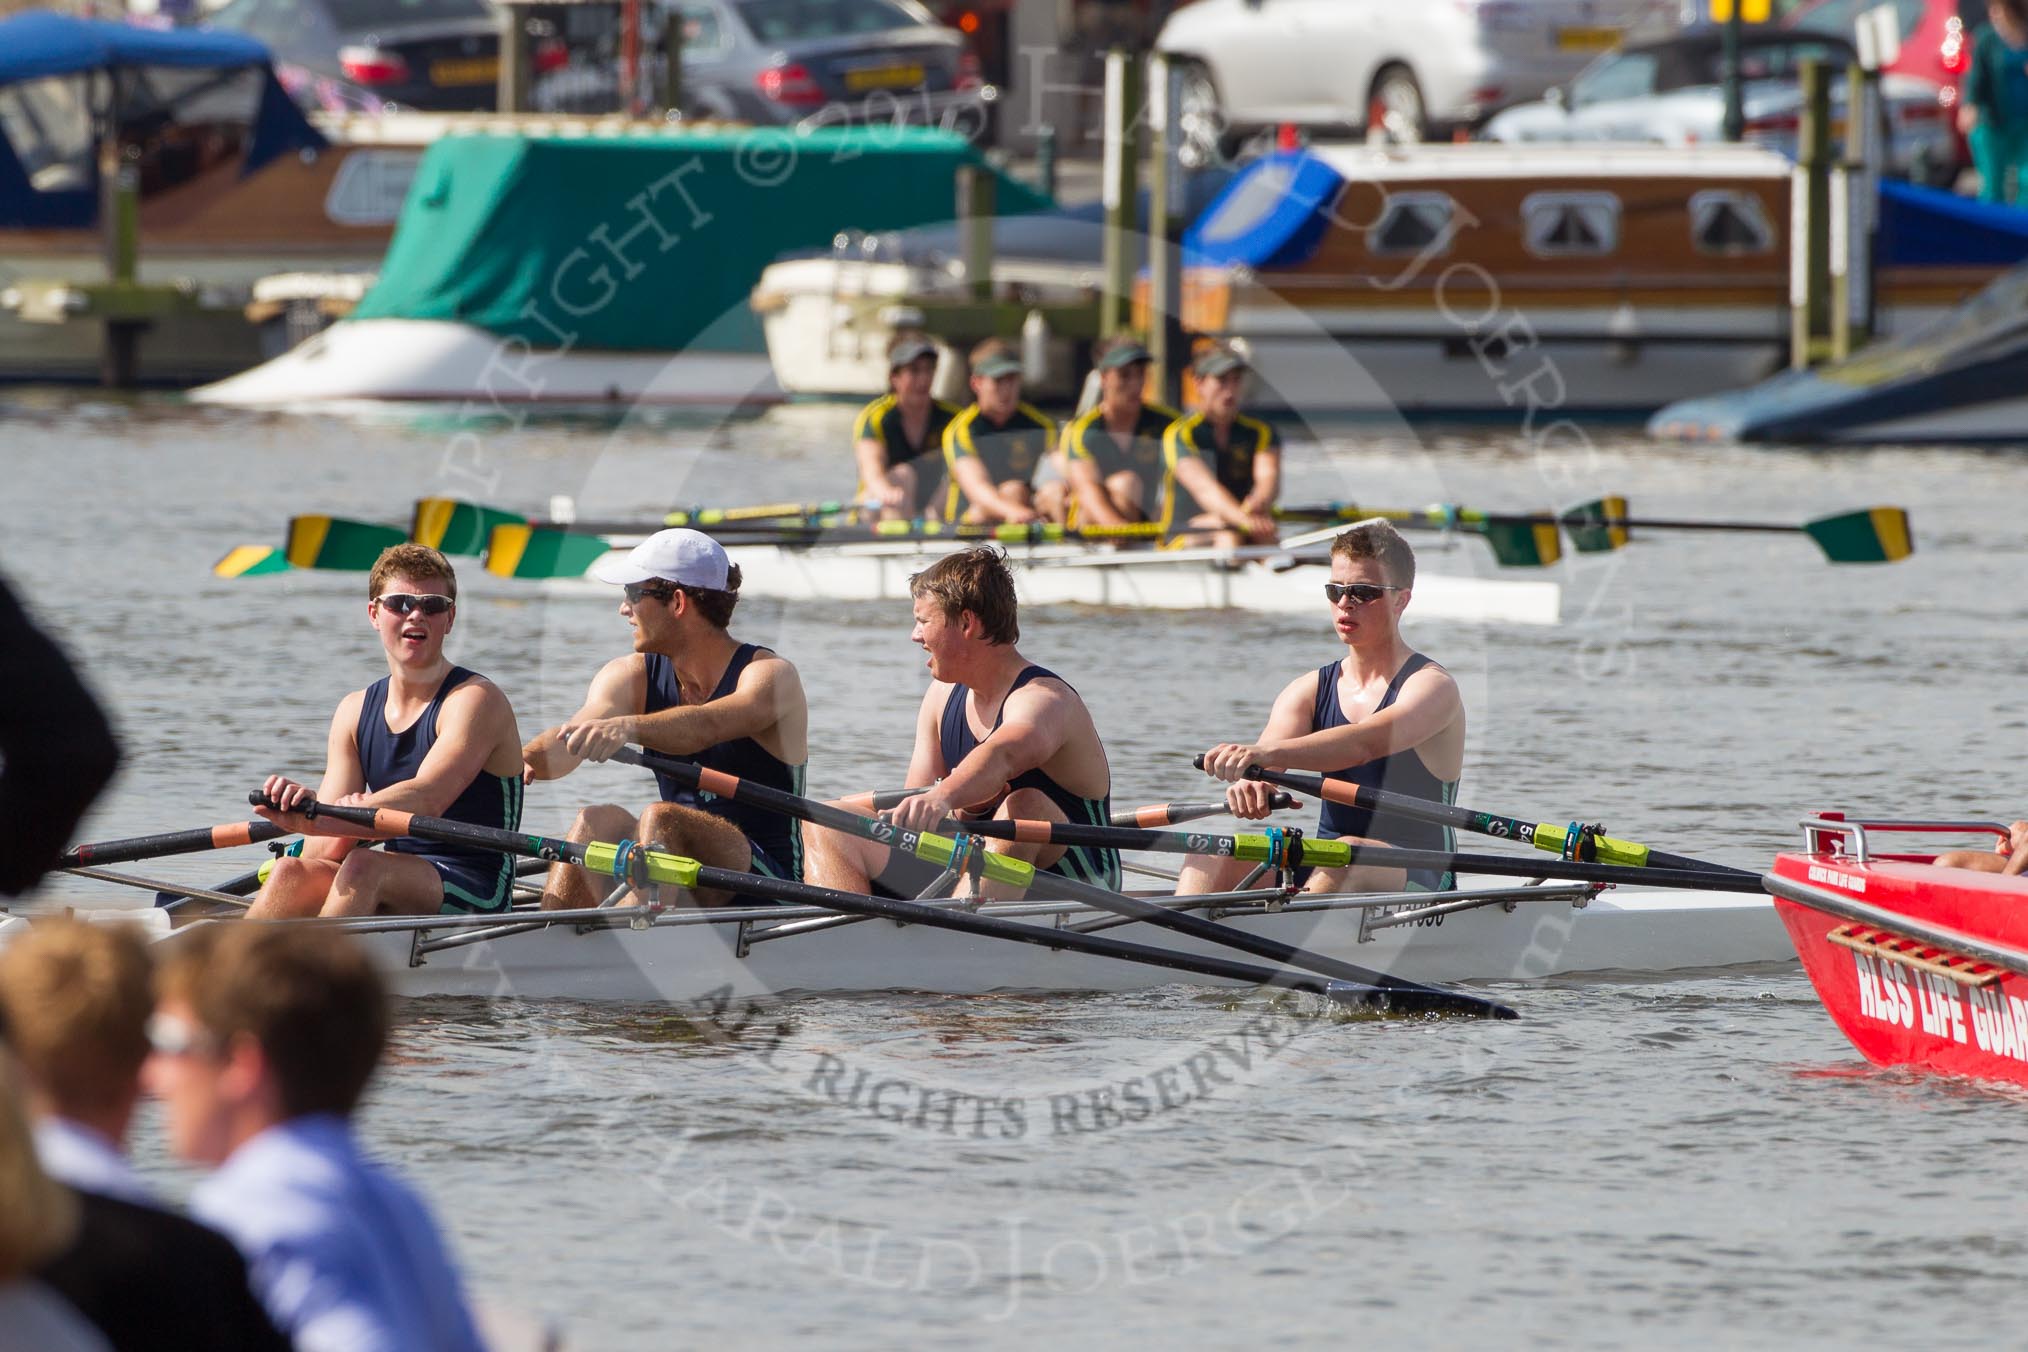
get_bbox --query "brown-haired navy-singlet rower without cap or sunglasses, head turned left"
[805,549,1119,898]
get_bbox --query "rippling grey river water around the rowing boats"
[0,393,2028,1348]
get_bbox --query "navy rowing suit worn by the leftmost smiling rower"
[353,667,521,912]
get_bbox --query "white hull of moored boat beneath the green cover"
[191,318,785,409]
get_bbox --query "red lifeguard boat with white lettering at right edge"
[1762,815,2028,1084]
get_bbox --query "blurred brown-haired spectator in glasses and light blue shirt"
[146,924,481,1352]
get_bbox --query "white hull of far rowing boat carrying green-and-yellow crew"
[555,539,1564,624]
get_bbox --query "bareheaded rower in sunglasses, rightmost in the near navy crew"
[1178,521,1464,894]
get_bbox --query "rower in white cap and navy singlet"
[523,529,809,910]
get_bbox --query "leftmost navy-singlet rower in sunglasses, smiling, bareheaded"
[247,545,521,918]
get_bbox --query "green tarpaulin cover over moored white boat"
[353,126,1053,353]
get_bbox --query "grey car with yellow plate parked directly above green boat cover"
[669,0,998,136]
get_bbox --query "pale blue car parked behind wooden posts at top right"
[1480,26,1953,176]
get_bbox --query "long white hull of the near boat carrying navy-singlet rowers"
[348,892,1795,1005]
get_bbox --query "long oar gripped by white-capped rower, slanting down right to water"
[610,746,1517,1018]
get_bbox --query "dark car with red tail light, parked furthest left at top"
[207,0,519,111]
